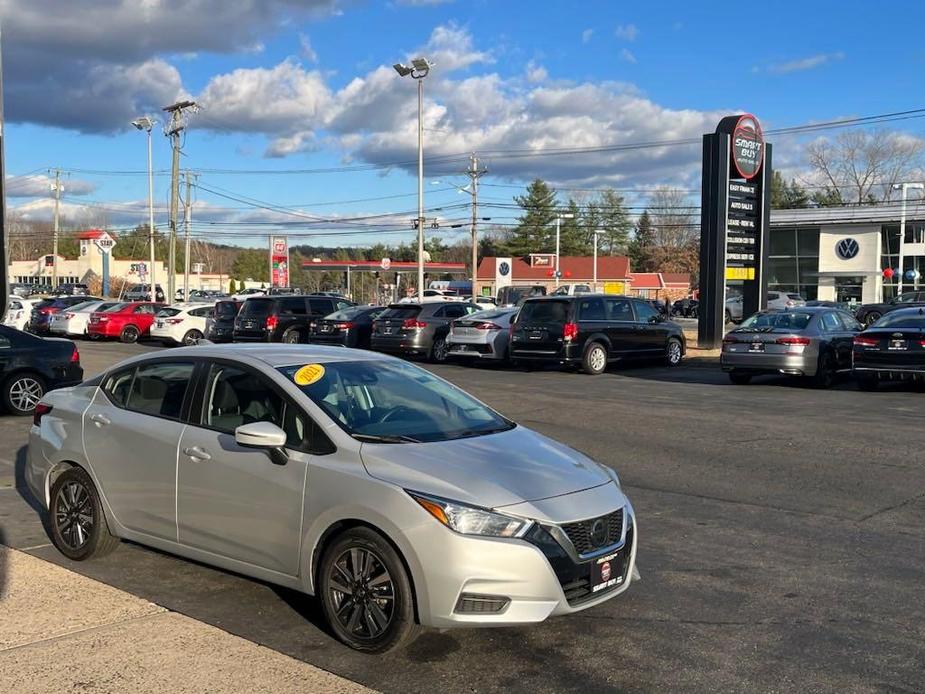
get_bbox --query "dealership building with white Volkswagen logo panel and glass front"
[767,201,925,303]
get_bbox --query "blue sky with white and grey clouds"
[0,0,925,250]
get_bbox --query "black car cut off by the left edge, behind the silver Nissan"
[0,325,84,415]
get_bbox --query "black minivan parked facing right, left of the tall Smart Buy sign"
[511,294,686,374]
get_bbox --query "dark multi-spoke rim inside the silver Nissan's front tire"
[328,547,395,640]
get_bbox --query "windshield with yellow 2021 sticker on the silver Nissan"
[279,359,515,443]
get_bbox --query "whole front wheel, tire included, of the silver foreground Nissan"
[318,527,419,653]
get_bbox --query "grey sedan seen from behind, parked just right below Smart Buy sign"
[720,306,862,388]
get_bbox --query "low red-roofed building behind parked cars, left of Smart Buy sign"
[476,253,690,300]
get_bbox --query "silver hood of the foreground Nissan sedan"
[360,426,613,508]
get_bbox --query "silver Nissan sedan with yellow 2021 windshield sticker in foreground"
[26,345,638,652]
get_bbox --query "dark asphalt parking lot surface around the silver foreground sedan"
[0,343,925,692]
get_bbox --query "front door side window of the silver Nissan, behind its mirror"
[203,364,283,434]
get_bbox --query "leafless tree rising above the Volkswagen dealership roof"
[807,130,925,203]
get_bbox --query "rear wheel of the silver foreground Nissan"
[48,467,119,561]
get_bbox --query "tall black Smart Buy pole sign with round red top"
[698,113,771,349]
